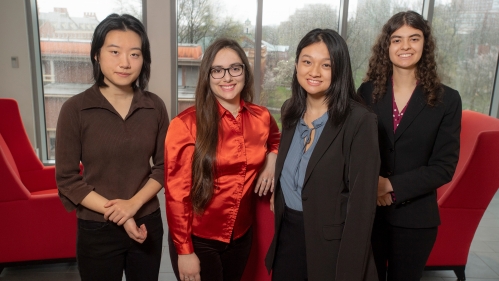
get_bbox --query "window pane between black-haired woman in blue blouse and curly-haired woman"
[346,0,423,87]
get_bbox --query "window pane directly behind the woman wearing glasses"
[177,0,256,113]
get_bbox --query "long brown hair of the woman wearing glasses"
[190,38,254,214]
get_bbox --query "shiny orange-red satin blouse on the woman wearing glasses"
[165,101,281,254]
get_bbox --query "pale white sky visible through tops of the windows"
[37,0,357,25]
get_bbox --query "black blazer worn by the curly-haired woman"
[358,82,462,228]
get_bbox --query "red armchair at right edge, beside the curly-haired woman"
[426,110,499,280]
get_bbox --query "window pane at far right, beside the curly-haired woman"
[432,0,499,114]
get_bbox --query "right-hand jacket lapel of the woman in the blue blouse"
[302,119,343,188]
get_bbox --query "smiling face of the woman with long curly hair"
[389,25,424,70]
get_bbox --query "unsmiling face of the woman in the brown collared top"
[96,30,144,89]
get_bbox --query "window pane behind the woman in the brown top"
[37,0,142,160]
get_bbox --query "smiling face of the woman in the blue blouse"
[296,41,332,97]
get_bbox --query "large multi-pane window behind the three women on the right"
[173,0,499,123]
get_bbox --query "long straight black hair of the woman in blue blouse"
[281,28,361,129]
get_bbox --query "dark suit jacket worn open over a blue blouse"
[265,101,380,281]
